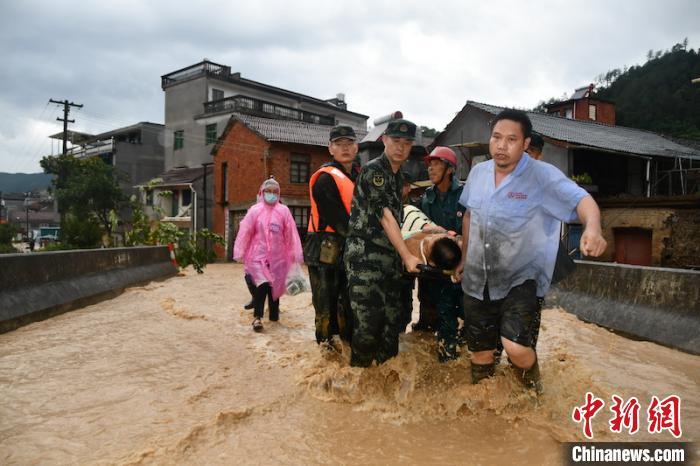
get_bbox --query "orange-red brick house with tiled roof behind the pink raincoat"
[212,113,365,260]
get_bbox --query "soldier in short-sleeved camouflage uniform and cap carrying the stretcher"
[345,120,420,367]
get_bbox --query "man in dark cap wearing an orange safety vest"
[304,125,360,351]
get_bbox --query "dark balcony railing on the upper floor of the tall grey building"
[204,95,335,126]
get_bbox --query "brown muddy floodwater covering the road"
[0,264,700,465]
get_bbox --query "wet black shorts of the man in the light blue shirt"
[464,280,540,352]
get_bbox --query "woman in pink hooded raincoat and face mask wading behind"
[233,178,304,332]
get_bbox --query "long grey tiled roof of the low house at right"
[464,101,700,160]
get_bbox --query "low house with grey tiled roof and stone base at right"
[433,97,700,268]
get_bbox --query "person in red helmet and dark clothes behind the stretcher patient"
[414,146,464,362]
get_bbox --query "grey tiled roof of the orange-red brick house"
[231,113,367,147]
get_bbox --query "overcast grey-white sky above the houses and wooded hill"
[0,0,700,173]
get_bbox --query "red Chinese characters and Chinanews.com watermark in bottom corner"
[564,392,696,465]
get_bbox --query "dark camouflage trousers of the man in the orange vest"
[309,263,352,343]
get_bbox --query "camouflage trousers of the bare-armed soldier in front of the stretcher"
[345,237,402,367]
